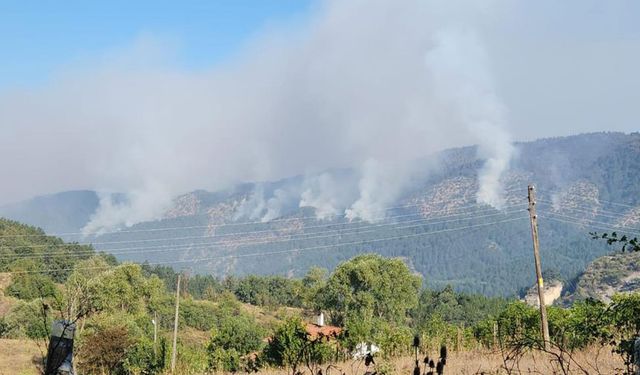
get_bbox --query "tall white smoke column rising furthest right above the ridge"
[427,30,515,208]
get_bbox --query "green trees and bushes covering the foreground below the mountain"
[0,219,640,374]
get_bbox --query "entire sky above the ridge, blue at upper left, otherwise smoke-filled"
[0,0,640,217]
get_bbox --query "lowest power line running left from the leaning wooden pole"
[6,216,525,274]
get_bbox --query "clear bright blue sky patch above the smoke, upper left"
[0,0,312,88]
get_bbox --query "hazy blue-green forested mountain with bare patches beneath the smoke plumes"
[0,133,640,295]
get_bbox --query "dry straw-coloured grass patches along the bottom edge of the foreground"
[0,339,622,375]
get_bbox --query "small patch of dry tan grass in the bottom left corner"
[0,339,40,375]
